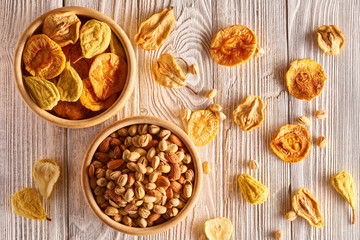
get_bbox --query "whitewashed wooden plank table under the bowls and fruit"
[0,0,360,240]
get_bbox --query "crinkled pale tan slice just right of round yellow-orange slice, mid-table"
[233,95,264,131]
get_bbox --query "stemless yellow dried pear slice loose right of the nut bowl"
[238,173,269,204]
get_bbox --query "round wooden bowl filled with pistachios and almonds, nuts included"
[81,116,202,235]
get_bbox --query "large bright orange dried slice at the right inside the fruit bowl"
[89,53,127,100]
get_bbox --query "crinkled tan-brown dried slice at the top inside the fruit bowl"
[43,12,81,47]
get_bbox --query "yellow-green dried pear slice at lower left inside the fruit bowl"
[24,76,60,110]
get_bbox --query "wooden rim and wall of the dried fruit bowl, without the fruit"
[13,7,137,128]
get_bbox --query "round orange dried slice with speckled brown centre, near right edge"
[286,59,326,101]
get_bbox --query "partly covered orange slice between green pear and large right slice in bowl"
[80,78,118,111]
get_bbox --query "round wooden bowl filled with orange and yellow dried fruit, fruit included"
[13,7,136,128]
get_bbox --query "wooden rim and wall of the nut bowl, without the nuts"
[81,116,203,235]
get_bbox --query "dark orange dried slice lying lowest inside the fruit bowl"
[53,100,89,120]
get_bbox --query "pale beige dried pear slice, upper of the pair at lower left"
[33,159,60,199]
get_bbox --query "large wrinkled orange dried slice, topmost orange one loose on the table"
[210,25,256,66]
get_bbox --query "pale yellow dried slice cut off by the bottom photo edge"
[204,217,233,240]
